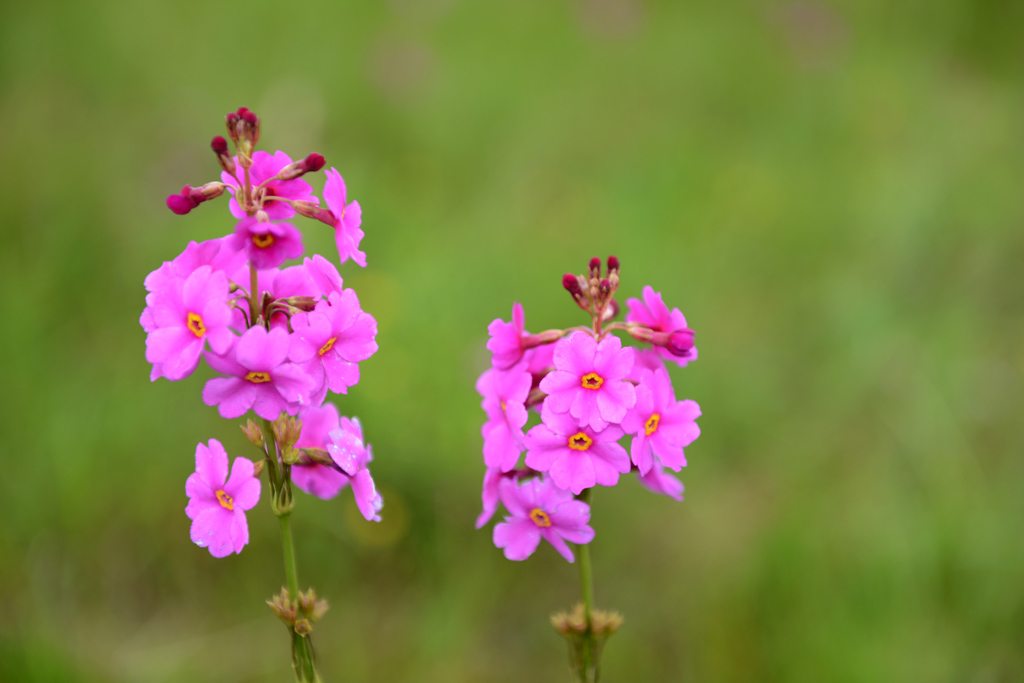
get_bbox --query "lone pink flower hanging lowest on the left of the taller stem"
[185,438,260,557]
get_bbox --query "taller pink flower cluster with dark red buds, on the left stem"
[151,108,383,557]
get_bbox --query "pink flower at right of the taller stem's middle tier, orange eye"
[290,290,377,403]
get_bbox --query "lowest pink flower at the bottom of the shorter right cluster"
[494,477,594,562]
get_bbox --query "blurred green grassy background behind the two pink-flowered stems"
[0,0,1024,683]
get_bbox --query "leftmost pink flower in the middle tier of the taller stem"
[141,265,234,381]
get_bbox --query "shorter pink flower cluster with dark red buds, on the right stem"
[476,256,700,562]
